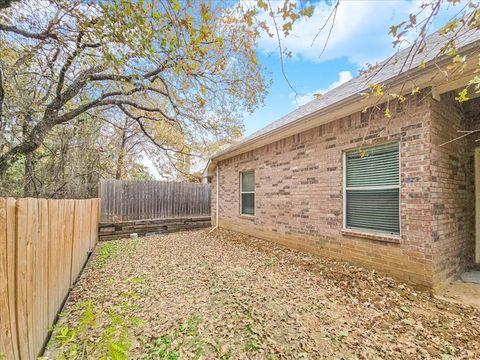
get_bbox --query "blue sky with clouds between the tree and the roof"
[244,0,465,136]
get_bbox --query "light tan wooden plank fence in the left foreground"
[0,198,100,360]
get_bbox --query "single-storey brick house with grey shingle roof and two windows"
[207,31,480,287]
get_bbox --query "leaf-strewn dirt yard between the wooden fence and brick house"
[45,230,480,360]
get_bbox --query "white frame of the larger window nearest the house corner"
[342,143,402,238]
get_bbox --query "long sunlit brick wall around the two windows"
[212,94,478,286]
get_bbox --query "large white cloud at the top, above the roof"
[259,0,459,67]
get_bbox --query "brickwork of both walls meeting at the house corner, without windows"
[212,91,478,286]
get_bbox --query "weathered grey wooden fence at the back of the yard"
[100,180,211,222]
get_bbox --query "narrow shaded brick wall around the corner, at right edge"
[430,93,480,281]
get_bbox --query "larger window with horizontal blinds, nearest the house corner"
[344,143,400,235]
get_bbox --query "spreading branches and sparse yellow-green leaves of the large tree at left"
[0,0,311,183]
